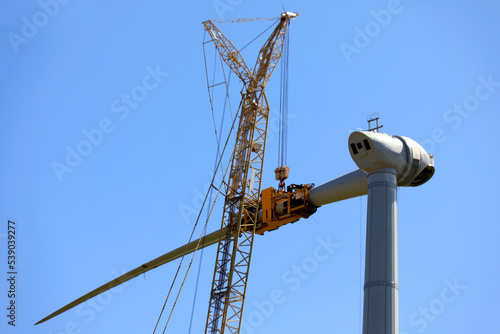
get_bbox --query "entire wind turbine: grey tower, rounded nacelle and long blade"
[37,127,434,334]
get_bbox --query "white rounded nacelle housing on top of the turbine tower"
[349,131,434,187]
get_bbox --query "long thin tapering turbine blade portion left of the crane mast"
[35,230,226,325]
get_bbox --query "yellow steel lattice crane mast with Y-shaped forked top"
[203,12,298,334]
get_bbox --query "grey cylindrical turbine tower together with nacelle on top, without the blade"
[349,131,434,334]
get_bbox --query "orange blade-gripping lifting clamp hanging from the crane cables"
[255,184,317,234]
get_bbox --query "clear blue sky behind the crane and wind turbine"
[0,0,500,334]
